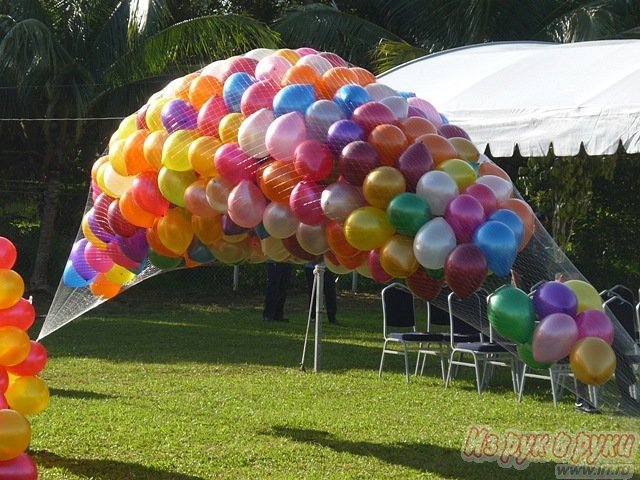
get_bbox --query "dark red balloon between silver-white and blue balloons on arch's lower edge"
[444,243,488,298]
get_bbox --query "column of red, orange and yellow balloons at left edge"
[0,237,49,480]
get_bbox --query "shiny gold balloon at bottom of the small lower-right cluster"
[569,337,616,385]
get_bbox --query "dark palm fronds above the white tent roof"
[274,0,640,71]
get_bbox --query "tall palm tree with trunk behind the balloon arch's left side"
[0,0,279,290]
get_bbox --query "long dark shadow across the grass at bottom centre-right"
[266,426,555,480]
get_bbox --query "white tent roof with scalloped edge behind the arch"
[379,40,640,157]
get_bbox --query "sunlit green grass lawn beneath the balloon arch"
[30,288,640,480]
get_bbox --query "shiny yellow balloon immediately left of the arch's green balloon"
[344,207,394,250]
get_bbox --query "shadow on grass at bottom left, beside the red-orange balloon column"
[30,450,204,480]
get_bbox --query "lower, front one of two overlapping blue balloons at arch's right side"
[473,220,520,277]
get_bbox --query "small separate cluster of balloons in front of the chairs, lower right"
[488,280,616,385]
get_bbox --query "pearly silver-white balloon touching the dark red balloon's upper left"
[413,217,456,270]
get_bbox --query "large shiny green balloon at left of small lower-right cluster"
[487,286,536,343]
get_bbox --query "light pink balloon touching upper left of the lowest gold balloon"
[531,313,578,363]
